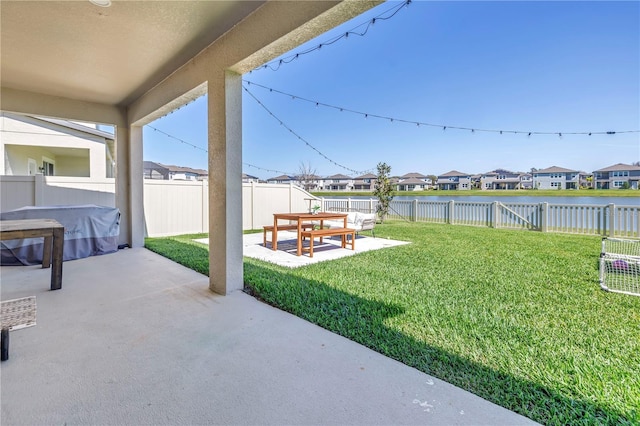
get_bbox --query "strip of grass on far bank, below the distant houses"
[312,189,640,198]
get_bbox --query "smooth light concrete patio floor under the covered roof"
[0,248,532,425]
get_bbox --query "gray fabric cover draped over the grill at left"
[0,204,120,265]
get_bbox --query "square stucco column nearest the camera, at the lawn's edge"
[208,70,243,295]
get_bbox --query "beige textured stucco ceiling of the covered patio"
[0,0,264,106]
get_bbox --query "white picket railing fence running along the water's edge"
[322,198,640,238]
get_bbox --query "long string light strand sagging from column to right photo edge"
[243,80,640,137]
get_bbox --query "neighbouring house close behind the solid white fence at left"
[0,112,116,179]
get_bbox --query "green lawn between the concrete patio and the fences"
[147,222,640,425]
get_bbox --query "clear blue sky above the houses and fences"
[144,1,640,179]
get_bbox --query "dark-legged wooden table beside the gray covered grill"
[0,219,64,290]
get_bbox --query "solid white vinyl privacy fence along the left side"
[0,175,316,237]
